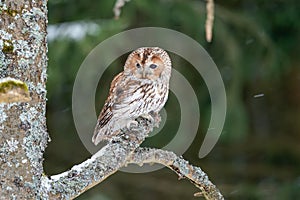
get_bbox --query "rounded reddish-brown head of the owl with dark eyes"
[124,47,172,82]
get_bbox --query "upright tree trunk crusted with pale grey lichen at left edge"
[0,0,48,199]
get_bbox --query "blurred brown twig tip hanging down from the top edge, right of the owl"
[205,0,215,42]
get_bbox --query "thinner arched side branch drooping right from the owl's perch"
[127,148,224,200]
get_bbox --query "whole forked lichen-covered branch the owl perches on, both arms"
[39,113,223,200]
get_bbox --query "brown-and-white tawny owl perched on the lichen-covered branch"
[92,47,171,145]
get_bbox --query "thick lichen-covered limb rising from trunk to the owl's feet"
[40,117,160,199]
